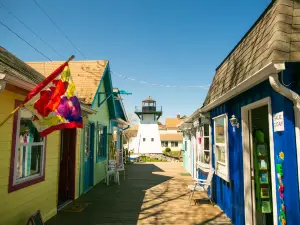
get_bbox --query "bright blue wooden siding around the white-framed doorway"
[207,63,300,225]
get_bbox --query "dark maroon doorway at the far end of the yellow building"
[58,129,76,209]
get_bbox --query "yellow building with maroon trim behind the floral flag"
[0,47,95,225]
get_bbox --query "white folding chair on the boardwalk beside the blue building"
[188,168,215,204]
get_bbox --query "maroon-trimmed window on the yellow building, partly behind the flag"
[8,101,45,192]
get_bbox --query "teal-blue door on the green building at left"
[84,124,94,191]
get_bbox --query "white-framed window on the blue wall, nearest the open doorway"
[214,115,229,182]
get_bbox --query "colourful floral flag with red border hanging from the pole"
[24,62,83,136]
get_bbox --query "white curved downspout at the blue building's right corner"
[269,68,300,197]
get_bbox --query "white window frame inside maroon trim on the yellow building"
[13,108,46,185]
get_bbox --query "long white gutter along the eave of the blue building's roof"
[200,62,284,113]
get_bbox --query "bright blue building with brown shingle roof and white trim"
[181,0,300,225]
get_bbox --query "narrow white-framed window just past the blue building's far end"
[198,124,211,168]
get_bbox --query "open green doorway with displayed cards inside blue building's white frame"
[249,105,273,225]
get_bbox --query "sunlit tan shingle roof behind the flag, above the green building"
[27,60,108,105]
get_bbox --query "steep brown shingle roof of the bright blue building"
[204,0,300,106]
